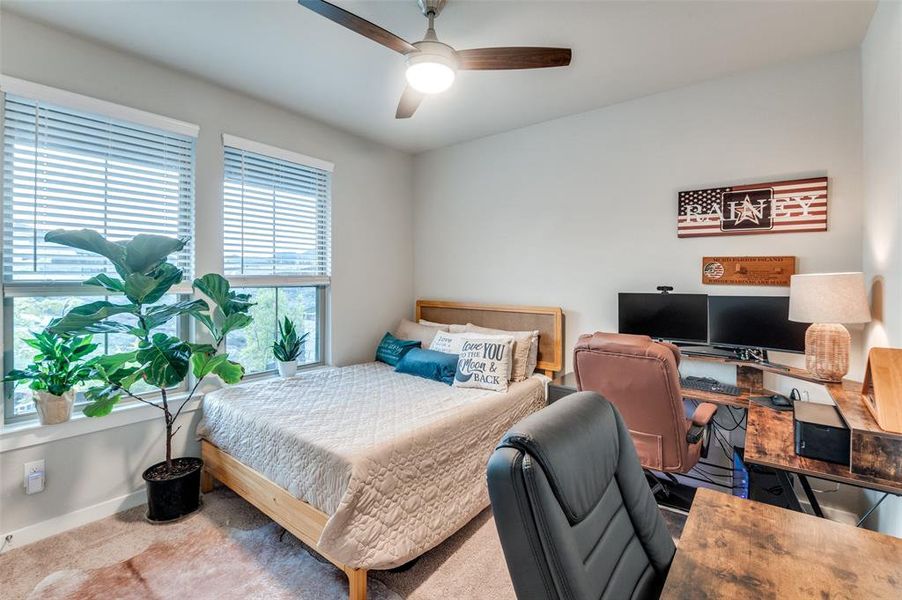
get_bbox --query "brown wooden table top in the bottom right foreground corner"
[661,488,902,600]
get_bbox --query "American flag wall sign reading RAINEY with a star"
[677,177,827,238]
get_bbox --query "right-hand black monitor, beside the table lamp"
[708,296,808,352]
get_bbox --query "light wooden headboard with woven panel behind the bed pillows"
[416,300,564,377]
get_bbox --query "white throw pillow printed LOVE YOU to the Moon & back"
[454,337,513,392]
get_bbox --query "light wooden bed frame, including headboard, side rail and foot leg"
[201,300,564,600]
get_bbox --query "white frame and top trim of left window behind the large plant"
[0,75,200,424]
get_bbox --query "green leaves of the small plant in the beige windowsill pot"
[3,330,97,396]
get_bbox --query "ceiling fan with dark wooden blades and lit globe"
[298,0,571,119]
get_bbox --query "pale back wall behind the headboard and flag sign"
[414,51,861,376]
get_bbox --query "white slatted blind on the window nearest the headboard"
[223,145,332,277]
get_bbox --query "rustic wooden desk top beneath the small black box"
[744,402,902,494]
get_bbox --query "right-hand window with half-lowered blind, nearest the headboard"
[223,136,332,373]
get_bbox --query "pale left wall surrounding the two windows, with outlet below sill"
[0,13,413,533]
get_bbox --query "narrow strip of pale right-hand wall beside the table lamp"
[861,2,902,537]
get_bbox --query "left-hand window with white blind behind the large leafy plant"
[2,78,197,421]
